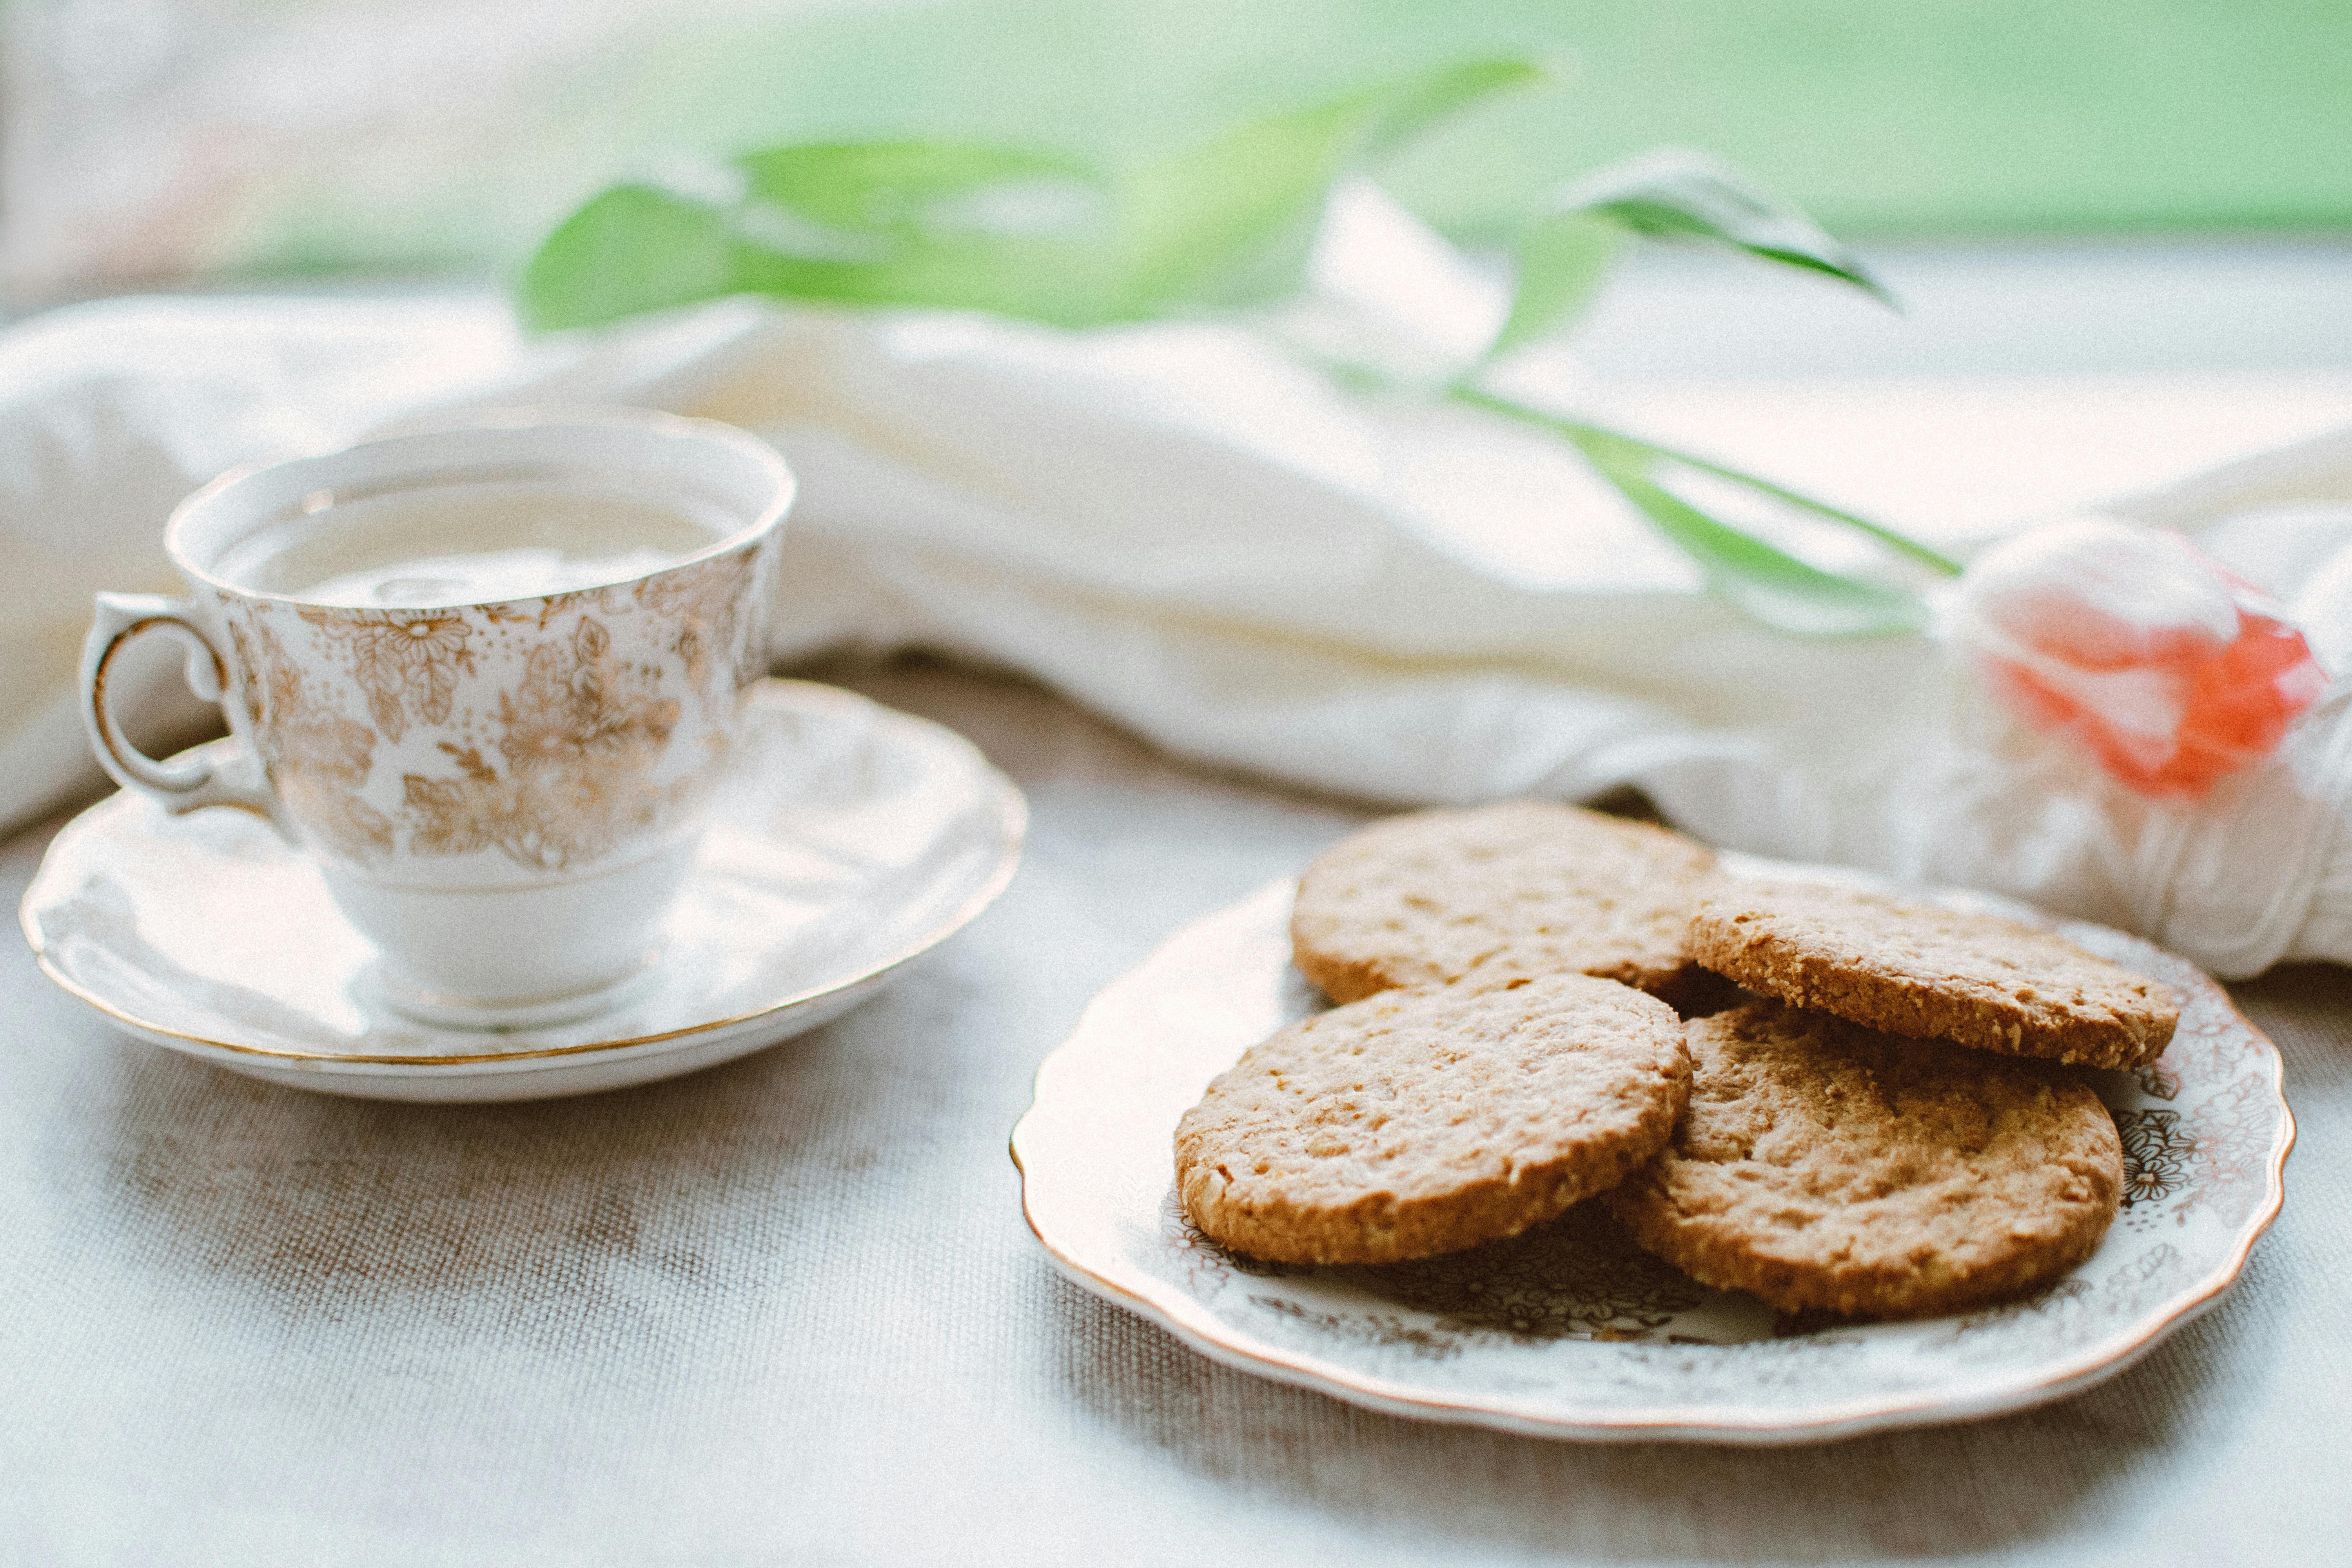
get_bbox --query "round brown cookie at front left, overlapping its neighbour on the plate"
[1176,976,1691,1262]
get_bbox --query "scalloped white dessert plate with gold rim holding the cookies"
[1014,856,2296,1443]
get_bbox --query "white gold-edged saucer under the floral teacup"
[21,679,1028,1103]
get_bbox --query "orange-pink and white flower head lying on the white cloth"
[1950,517,2328,797]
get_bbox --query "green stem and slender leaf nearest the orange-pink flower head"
[1454,388,1943,637]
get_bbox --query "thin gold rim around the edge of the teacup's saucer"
[16,677,1028,1067]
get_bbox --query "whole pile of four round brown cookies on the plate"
[1176,802,2178,1316]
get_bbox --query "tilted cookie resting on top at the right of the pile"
[1691,879,2180,1067]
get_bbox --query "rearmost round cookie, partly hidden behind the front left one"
[1291,799,1715,1002]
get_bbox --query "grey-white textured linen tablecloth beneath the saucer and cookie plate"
[0,668,2352,1568]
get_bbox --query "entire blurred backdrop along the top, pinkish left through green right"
[0,0,2352,297]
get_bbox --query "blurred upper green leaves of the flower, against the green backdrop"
[515,69,1893,338]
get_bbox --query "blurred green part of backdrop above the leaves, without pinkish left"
[254,0,2352,270]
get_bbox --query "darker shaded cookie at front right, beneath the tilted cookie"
[1609,1002,2124,1316]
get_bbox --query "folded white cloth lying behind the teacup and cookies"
[0,281,2352,976]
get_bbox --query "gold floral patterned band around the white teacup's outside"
[219,548,764,872]
